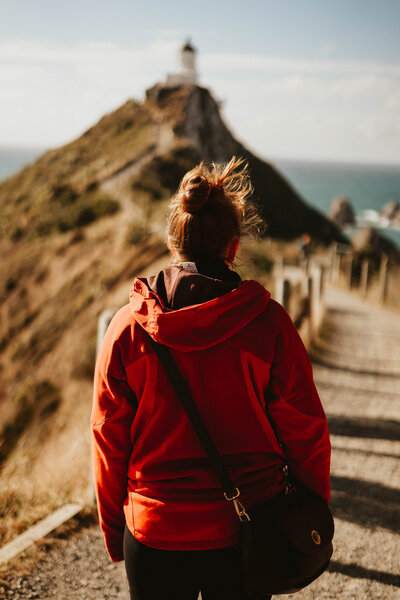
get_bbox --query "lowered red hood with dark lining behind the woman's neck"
[130,266,270,352]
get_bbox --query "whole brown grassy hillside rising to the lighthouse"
[0,86,341,539]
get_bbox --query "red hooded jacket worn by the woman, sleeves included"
[91,266,330,561]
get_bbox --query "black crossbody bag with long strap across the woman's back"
[148,336,334,595]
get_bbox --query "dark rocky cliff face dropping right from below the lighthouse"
[147,85,347,244]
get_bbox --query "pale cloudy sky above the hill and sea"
[0,0,400,164]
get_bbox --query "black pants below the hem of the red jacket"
[124,527,271,600]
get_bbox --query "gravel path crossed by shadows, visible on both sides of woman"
[0,289,400,600]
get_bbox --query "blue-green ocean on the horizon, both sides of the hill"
[0,147,400,247]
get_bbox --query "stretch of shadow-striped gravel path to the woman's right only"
[288,289,400,600]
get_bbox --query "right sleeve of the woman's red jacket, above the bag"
[266,310,331,500]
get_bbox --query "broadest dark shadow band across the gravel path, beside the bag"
[329,475,400,533]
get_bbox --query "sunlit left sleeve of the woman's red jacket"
[91,324,137,562]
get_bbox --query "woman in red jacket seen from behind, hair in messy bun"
[91,158,330,600]
